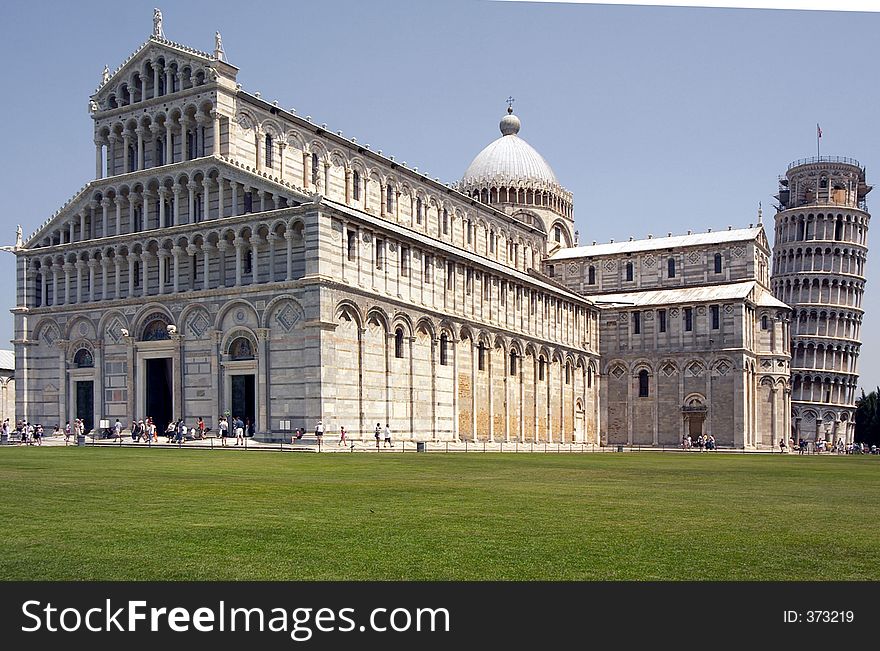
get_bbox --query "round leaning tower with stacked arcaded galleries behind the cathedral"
[772,156,871,443]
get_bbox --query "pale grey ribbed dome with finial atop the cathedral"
[459,108,559,188]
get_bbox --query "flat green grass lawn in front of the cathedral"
[0,447,880,580]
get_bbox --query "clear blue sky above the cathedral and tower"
[0,0,880,388]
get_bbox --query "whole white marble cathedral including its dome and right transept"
[13,13,867,448]
